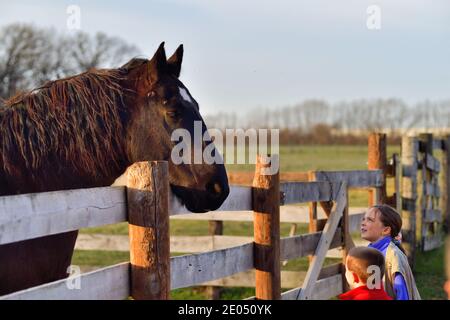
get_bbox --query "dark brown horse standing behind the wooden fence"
[0,43,229,295]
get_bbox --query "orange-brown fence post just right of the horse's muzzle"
[252,155,281,300]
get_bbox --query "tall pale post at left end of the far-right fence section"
[401,136,419,266]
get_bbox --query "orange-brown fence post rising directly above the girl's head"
[367,133,387,207]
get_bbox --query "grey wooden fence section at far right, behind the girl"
[402,134,450,265]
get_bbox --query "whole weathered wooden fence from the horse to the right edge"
[0,132,450,299]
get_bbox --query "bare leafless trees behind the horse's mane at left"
[0,24,139,99]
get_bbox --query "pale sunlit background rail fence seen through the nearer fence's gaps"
[72,170,384,299]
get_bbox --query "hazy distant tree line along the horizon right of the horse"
[205,98,450,144]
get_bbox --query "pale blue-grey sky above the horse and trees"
[0,0,450,115]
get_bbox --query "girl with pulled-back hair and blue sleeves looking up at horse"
[361,204,420,300]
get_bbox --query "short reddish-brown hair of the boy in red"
[347,247,385,283]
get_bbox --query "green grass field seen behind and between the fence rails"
[72,146,445,299]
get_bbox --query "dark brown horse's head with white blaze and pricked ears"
[121,43,229,212]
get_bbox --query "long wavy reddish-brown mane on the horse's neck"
[0,68,134,180]
